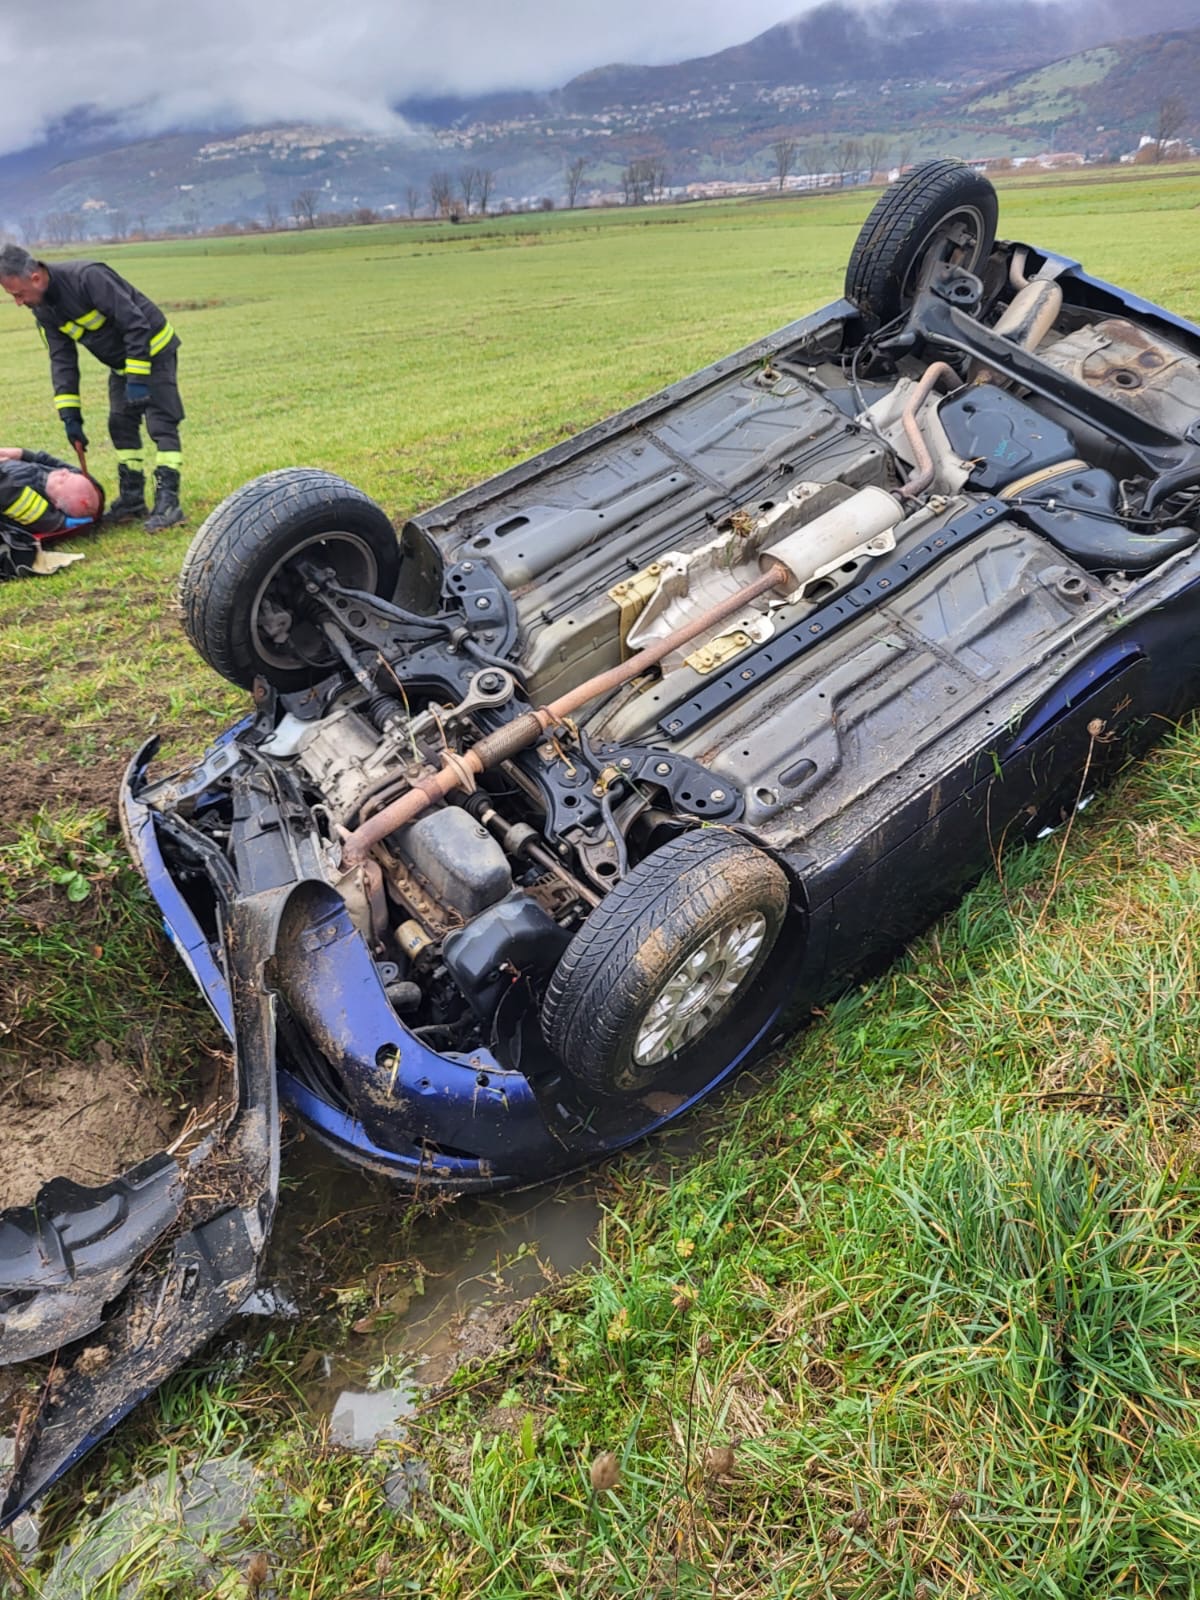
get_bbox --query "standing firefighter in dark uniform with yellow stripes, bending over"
[0,245,184,533]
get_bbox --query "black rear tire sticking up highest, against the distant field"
[846,158,1000,328]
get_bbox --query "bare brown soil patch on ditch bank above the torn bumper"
[0,1043,178,1210]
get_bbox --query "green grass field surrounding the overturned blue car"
[0,168,1200,1600]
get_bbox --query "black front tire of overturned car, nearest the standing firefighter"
[179,467,400,690]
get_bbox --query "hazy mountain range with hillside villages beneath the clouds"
[0,0,1200,243]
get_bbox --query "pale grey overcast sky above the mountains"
[0,0,814,154]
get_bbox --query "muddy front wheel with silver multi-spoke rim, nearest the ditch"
[542,829,789,1096]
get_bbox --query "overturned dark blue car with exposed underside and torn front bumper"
[0,160,1200,1514]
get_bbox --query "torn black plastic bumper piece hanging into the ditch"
[0,870,286,1528]
